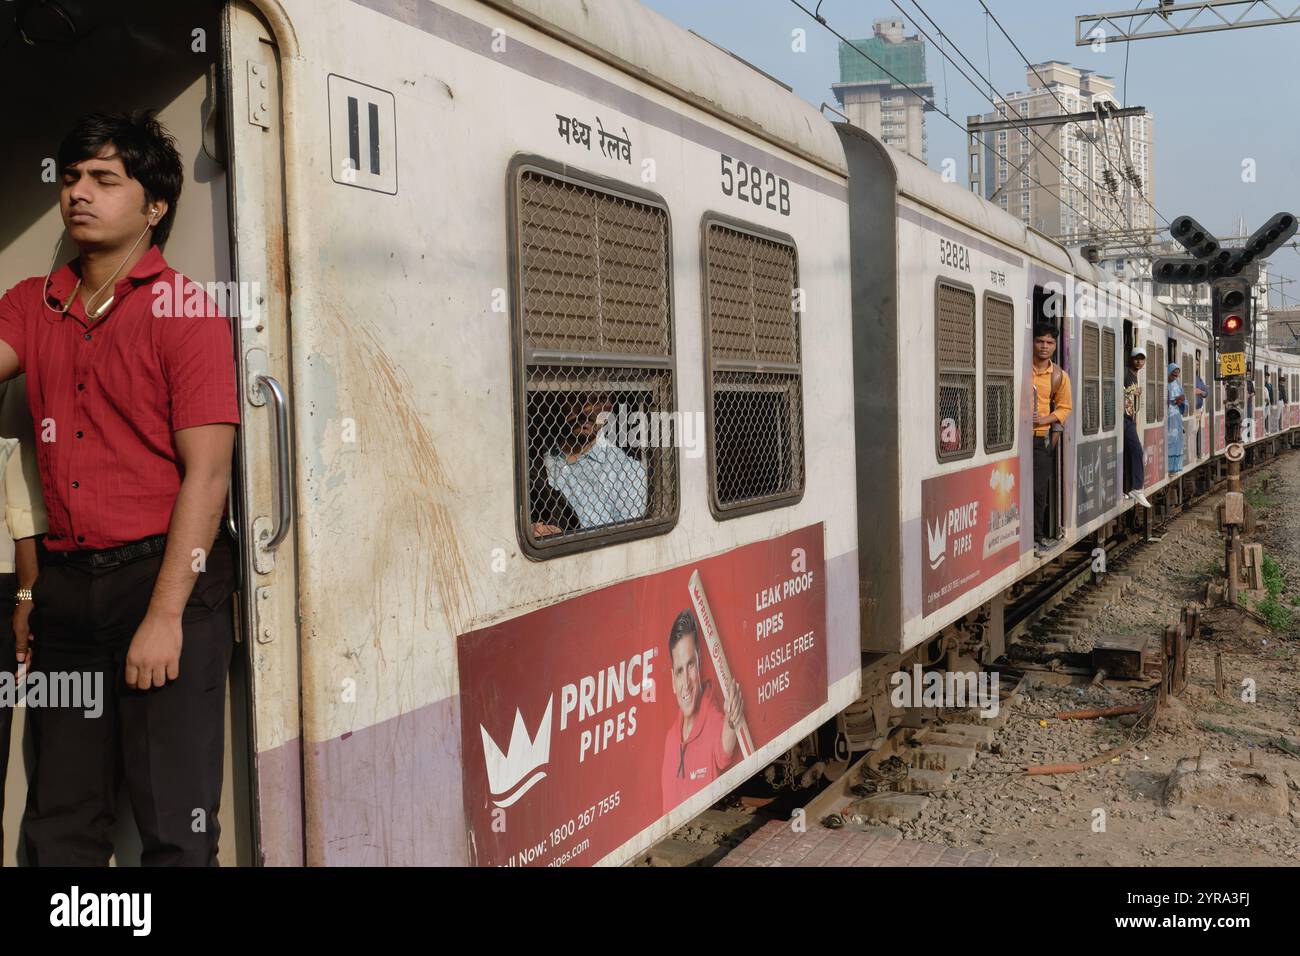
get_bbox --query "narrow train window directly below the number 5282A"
[935,281,975,462]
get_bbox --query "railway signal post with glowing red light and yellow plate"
[1151,212,1296,606]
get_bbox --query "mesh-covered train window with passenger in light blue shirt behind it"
[512,164,677,557]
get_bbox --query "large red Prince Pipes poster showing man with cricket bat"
[458,524,828,866]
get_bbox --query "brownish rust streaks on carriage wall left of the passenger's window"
[334,316,473,642]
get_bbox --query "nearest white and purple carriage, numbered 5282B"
[10,0,859,865]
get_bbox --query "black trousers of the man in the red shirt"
[22,536,235,866]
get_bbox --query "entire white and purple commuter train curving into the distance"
[0,0,1300,865]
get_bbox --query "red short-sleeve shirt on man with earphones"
[0,246,239,551]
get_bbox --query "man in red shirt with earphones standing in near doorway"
[0,113,239,866]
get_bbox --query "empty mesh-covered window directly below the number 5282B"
[705,220,803,518]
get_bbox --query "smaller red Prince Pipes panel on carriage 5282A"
[920,458,1021,615]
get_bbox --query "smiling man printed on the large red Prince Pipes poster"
[662,610,742,813]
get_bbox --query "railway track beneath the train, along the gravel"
[644,444,1294,866]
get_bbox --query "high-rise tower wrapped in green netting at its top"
[831,18,935,163]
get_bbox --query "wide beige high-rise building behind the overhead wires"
[969,60,1154,242]
